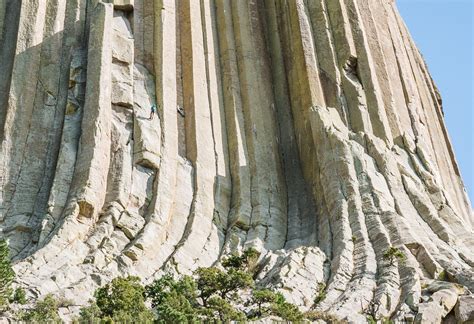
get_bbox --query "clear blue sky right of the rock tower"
[397,0,474,204]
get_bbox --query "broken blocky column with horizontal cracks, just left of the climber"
[96,2,139,271]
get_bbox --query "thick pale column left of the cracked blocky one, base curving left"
[11,2,113,300]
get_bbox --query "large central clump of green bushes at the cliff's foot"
[77,249,310,323]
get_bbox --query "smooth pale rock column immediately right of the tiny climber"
[133,0,178,275]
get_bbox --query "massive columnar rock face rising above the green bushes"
[0,0,474,321]
